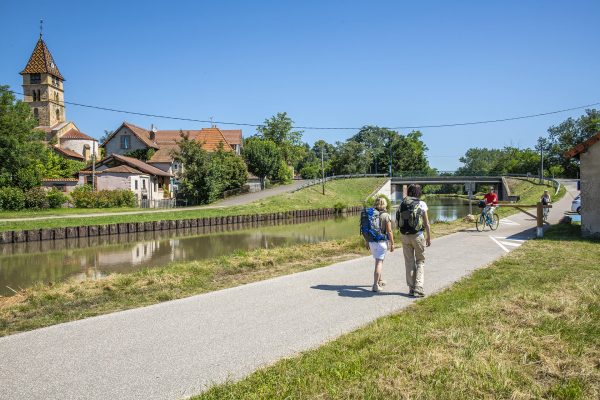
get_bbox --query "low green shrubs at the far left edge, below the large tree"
[0,187,67,211]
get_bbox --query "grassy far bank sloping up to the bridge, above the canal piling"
[0,178,385,231]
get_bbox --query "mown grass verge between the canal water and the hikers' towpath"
[0,221,471,336]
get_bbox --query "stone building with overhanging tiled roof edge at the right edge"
[565,132,600,236]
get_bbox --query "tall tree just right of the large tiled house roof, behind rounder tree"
[256,112,307,169]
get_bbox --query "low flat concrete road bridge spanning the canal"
[389,175,510,200]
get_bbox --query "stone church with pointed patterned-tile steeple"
[21,34,98,161]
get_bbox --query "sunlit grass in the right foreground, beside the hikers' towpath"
[195,225,600,399]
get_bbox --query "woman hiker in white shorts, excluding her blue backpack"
[361,197,394,292]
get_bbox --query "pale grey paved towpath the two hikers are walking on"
[0,183,572,400]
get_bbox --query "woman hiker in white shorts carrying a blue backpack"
[360,197,394,292]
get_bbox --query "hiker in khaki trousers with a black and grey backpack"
[396,185,431,297]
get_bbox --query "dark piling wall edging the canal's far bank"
[0,206,362,244]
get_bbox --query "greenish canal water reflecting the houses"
[0,198,469,296]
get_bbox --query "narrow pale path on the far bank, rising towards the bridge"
[0,180,306,222]
